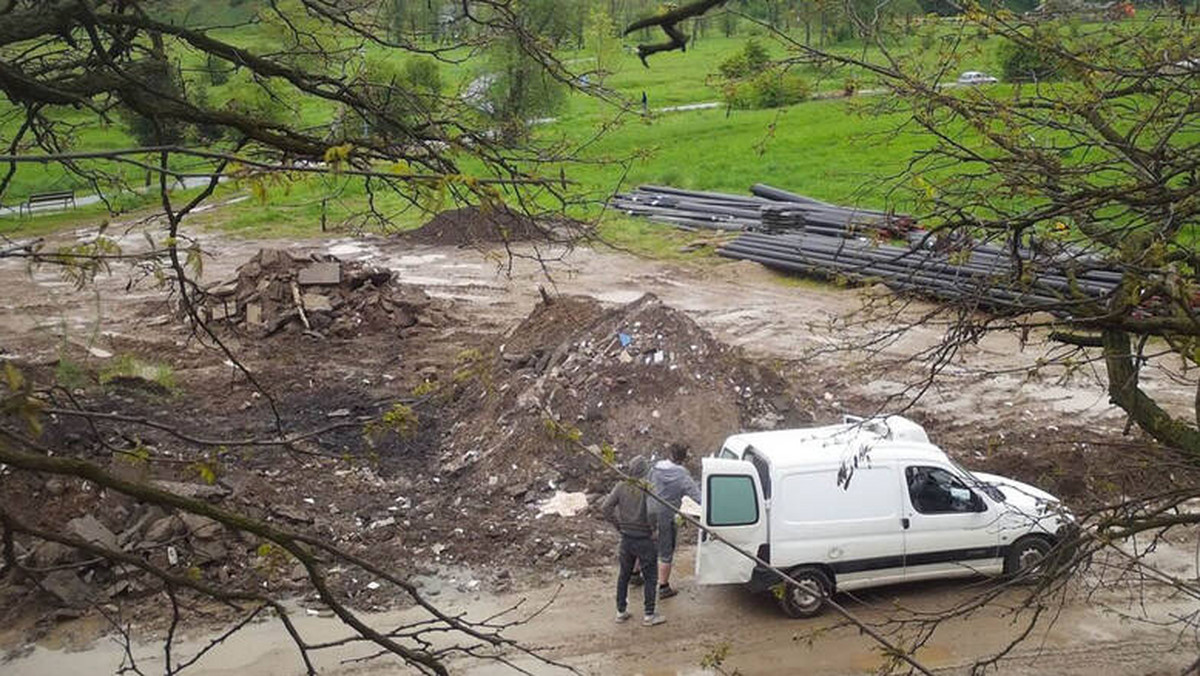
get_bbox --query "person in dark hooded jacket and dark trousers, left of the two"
[602,455,666,627]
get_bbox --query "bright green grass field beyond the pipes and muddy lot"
[0,19,1099,253]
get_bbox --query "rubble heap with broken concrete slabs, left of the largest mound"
[204,249,444,337]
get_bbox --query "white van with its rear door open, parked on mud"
[696,415,1074,617]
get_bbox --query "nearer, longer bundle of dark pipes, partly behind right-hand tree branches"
[718,233,1120,312]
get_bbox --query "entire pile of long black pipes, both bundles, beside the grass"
[612,184,1121,315]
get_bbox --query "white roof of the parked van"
[725,415,947,468]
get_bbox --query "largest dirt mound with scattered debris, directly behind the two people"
[432,294,811,499]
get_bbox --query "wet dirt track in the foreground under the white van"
[5,548,1195,676]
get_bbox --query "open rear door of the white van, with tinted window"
[696,457,767,585]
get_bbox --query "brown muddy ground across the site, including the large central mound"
[0,208,1195,674]
